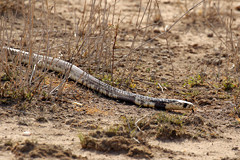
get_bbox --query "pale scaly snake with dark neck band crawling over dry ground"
[2,46,194,111]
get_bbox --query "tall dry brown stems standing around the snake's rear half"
[0,0,168,105]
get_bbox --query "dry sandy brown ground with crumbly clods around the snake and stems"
[0,0,240,160]
